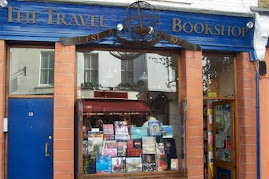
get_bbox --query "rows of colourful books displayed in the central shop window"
[82,121,178,174]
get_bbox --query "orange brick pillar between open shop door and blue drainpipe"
[236,52,257,179]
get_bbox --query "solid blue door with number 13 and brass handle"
[7,98,53,179]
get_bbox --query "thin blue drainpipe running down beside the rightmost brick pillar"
[256,60,261,179]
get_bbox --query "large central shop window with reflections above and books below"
[75,51,182,178]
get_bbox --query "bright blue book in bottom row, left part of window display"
[96,155,112,174]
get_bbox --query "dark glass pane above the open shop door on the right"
[203,56,234,97]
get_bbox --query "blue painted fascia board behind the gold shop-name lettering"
[0,0,254,56]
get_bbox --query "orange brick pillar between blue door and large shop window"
[54,43,76,179]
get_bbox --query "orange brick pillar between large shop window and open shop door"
[179,50,204,179]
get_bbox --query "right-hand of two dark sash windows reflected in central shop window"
[121,60,134,83]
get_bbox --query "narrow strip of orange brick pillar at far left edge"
[0,40,6,179]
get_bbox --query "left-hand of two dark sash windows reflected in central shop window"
[84,53,98,83]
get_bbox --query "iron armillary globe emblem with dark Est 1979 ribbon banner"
[60,0,201,51]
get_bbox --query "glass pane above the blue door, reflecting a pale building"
[9,48,54,95]
